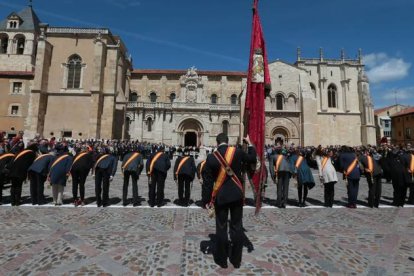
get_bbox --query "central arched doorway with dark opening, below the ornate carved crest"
[176,118,204,147]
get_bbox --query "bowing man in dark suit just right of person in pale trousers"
[70,146,93,206]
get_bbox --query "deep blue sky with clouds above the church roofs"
[0,0,414,108]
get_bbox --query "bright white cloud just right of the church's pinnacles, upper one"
[364,53,411,83]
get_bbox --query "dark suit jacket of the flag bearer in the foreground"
[202,144,256,205]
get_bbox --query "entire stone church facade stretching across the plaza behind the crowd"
[0,6,375,145]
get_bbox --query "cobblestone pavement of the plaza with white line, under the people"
[0,161,414,275]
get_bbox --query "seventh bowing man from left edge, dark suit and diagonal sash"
[122,148,144,207]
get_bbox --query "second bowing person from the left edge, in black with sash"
[9,144,37,206]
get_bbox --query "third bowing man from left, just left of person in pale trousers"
[28,147,55,205]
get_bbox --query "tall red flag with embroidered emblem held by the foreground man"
[244,0,270,213]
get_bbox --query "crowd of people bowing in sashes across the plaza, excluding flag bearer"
[0,134,414,208]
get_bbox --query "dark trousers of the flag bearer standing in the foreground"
[213,201,244,265]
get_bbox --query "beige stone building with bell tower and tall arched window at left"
[0,6,132,139]
